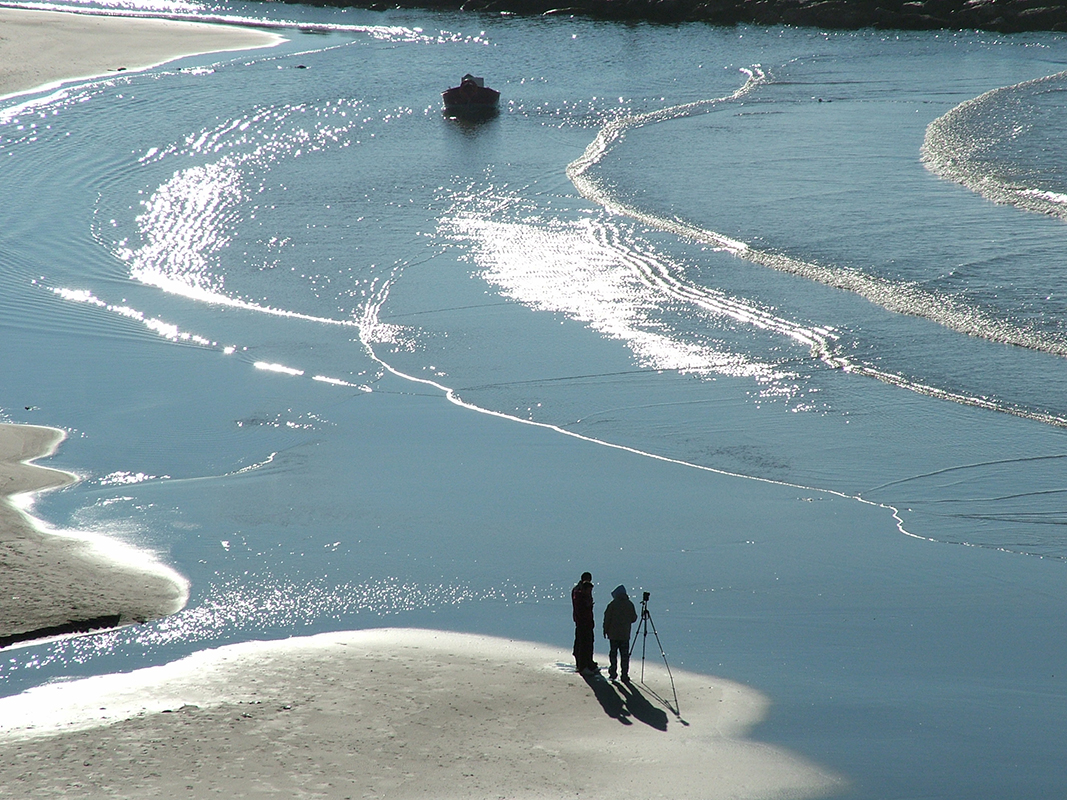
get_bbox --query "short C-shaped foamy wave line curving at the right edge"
[920,71,1067,222]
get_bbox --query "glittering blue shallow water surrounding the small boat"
[0,4,1067,798]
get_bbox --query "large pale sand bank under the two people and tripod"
[0,629,842,800]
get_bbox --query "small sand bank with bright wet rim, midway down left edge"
[0,425,188,644]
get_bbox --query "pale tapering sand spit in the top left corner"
[0,9,284,97]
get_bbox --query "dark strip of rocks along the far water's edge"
[319,0,1067,33]
